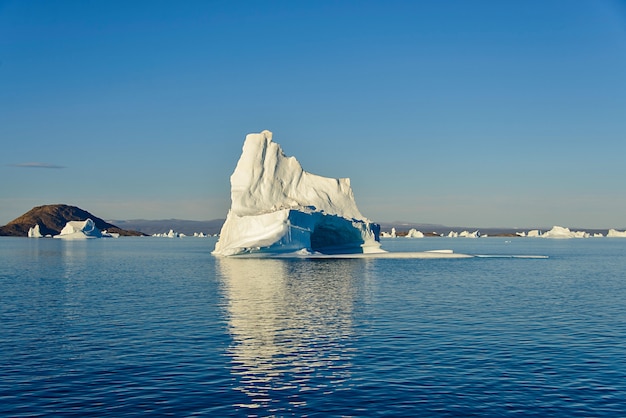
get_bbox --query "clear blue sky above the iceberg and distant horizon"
[0,0,626,228]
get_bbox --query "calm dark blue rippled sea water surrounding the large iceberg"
[0,238,626,417]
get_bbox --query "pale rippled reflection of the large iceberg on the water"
[217,258,367,412]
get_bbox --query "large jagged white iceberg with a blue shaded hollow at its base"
[213,131,384,256]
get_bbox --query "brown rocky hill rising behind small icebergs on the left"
[0,205,144,237]
